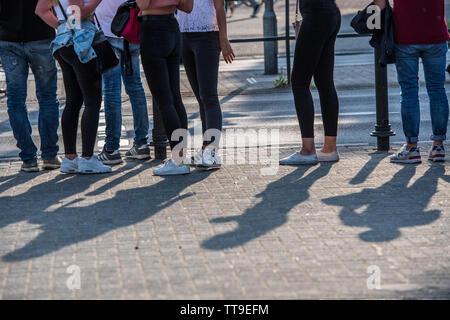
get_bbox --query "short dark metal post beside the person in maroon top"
[370,49,395,151]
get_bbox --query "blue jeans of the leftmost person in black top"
[0,40,59,162]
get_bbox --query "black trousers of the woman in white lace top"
[182,32,222,147]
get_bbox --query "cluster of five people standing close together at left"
[0,0,235,175]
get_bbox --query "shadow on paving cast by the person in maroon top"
[323,165,450,242]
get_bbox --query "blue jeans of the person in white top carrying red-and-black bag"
[103,37,149,151]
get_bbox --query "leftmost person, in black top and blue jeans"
[0,0,61,172]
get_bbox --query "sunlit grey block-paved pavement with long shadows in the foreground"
[0,148,450,299]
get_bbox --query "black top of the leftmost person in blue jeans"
[0,0,55,42]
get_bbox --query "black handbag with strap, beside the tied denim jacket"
[58,1,119,74]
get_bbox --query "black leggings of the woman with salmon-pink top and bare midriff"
[139,15,187,150]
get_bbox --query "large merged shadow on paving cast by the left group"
[0,162,209,262]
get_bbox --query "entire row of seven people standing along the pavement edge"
[0,0,449,175]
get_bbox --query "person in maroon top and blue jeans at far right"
[375,0,449,163]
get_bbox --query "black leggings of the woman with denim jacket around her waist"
[55,47,102,157]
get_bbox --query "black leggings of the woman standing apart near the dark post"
[292,8,341,138]
